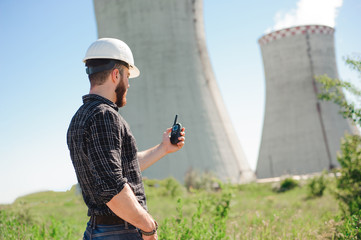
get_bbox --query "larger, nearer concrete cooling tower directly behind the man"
[94,0,254,182]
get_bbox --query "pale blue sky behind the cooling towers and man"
[0,0,361,203]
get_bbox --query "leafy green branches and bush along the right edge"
[317,58,361,239]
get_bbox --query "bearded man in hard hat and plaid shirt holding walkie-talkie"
[67,38,185,239]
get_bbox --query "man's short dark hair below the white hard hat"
[85,58,129,86]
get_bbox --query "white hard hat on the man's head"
[83,38,140,78]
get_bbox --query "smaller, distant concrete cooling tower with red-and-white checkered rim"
[256,25,351,178]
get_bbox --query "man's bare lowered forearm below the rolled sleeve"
[106,183,157,239]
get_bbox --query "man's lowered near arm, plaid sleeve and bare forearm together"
[87,111,156,240]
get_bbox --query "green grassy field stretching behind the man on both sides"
[0,179,339,239]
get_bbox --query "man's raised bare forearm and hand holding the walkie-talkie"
[137,128,185,171]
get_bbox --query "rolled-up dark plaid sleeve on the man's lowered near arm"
[88,111,127,203]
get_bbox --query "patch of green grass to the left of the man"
[0,187,87,239]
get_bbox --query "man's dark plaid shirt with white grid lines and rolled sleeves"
[67,94,147,216]
